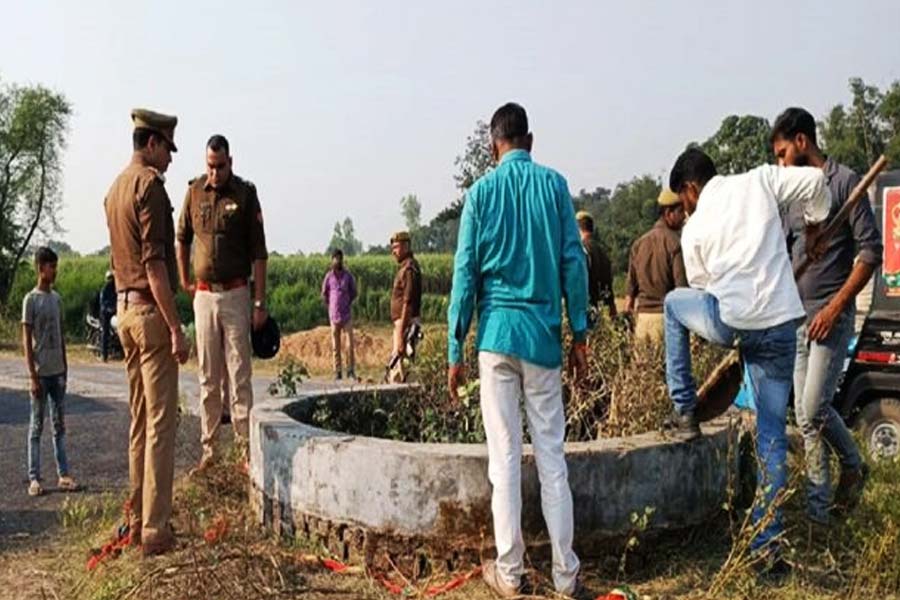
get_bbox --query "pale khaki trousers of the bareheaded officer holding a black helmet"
[194,286,253,460]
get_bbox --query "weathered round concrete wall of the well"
[250,386,737,554]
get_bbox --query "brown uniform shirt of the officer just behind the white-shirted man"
[625,218,687,313]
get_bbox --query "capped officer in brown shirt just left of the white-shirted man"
[625,188,688,344]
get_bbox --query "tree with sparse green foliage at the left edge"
[0,84,72,304]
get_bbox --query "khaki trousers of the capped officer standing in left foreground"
[118,303,178,545]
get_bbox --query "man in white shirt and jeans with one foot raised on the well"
[664,148,831,574]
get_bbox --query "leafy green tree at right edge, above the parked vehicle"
[818,77,900,173]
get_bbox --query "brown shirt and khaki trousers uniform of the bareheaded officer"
[178,174,268,460]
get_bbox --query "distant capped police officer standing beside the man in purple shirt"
[390,231,422,382]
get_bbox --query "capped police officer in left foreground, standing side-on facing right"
[105,109,189,555]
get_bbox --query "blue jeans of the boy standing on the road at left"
[28,373,69,481]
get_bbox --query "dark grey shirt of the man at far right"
[784,158,883,318]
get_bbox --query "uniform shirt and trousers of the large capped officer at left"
[105,162,178,547]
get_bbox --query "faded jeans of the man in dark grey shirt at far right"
[794,307,862,521]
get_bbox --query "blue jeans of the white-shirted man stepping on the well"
[664,288,797,552]
